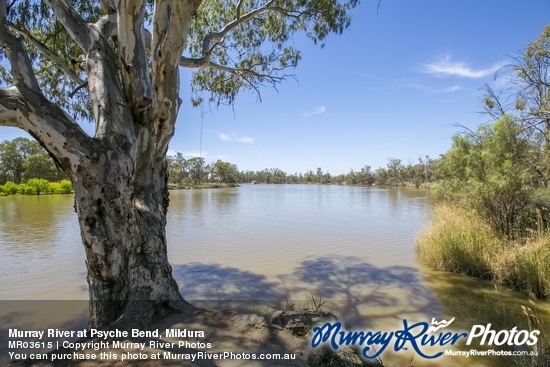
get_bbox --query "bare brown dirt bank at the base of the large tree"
[6,304,376,367]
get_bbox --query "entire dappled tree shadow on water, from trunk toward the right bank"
[173,256,439,327]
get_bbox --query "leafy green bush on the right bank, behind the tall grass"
[438,116,537,238]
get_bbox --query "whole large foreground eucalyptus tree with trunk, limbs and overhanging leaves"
[0,0,358,327]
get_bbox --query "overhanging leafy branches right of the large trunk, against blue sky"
[187,0,358,105]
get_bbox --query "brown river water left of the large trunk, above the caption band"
[0,195,87,299]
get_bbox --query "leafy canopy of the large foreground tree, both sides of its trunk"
[0,0,359,113]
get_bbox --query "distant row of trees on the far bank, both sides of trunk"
[0,138,441,193]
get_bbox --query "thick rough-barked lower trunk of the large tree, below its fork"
[73,144,183,327]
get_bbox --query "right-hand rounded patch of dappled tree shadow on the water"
[283,256,444,327]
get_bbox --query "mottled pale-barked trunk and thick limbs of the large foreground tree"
[0,0,200,327]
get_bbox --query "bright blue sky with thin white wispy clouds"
[0,0,550,174]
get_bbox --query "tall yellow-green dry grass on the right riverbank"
[417,204,550,299]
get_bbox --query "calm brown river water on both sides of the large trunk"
[0,185,550,366]
